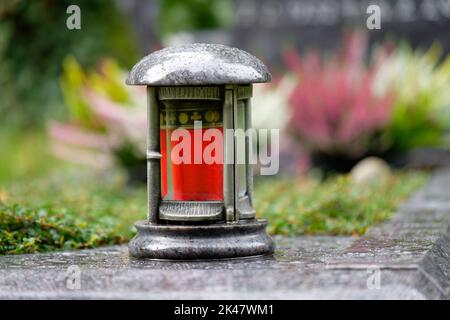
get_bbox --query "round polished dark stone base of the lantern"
[128,220,274,260]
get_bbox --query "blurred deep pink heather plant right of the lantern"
[284,33,392,158]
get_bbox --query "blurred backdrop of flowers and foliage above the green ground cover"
[0,0,450,182]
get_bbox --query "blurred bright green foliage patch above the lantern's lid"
[159,0,233,37]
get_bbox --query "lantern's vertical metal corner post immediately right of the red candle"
[223,85,235,222]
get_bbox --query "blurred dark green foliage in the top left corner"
[0,0,137,125]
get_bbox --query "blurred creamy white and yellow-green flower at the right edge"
[373,45,450,151]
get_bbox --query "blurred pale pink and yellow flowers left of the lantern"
[49,57,147,172]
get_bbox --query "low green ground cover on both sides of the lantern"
[0,171,427,254]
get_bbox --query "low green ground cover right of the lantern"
[255,172,427,236]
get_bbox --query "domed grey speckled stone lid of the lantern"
[126,43,272,86]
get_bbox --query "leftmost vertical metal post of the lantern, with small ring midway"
[147,86,161,223]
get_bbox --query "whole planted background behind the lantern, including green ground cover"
[0,0,450,254]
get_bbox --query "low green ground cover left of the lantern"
[0,171,146,254]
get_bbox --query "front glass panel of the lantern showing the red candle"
[160,99,223,201]
